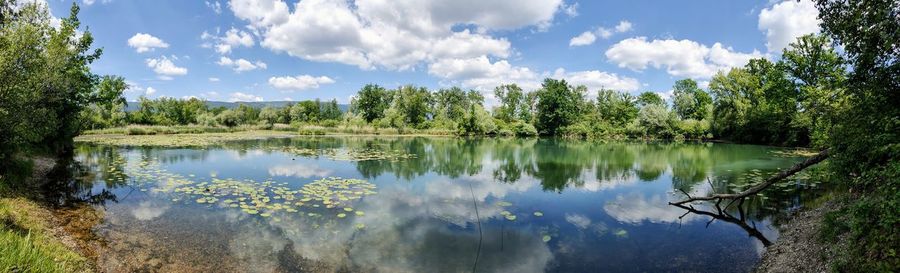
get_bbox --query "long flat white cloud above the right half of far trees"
[606,37,763,78]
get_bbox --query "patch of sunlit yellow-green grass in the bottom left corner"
[0,198,90,272]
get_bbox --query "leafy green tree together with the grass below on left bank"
[0,0,112,272]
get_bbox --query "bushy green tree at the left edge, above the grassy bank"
[0,1,101,163]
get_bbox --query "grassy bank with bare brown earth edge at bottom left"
[0,156,103,272]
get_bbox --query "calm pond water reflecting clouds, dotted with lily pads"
[65,137,815,272]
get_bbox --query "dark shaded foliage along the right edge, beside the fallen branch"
[807,0,900,272]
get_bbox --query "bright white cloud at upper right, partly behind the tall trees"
[759,0,819,52]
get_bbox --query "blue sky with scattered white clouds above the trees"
[37,0,818,104]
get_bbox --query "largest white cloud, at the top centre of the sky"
[230,0,564,70]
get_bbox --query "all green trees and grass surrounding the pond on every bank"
[0,0,900,272]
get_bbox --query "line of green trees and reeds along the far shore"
[82,30,849,147]
